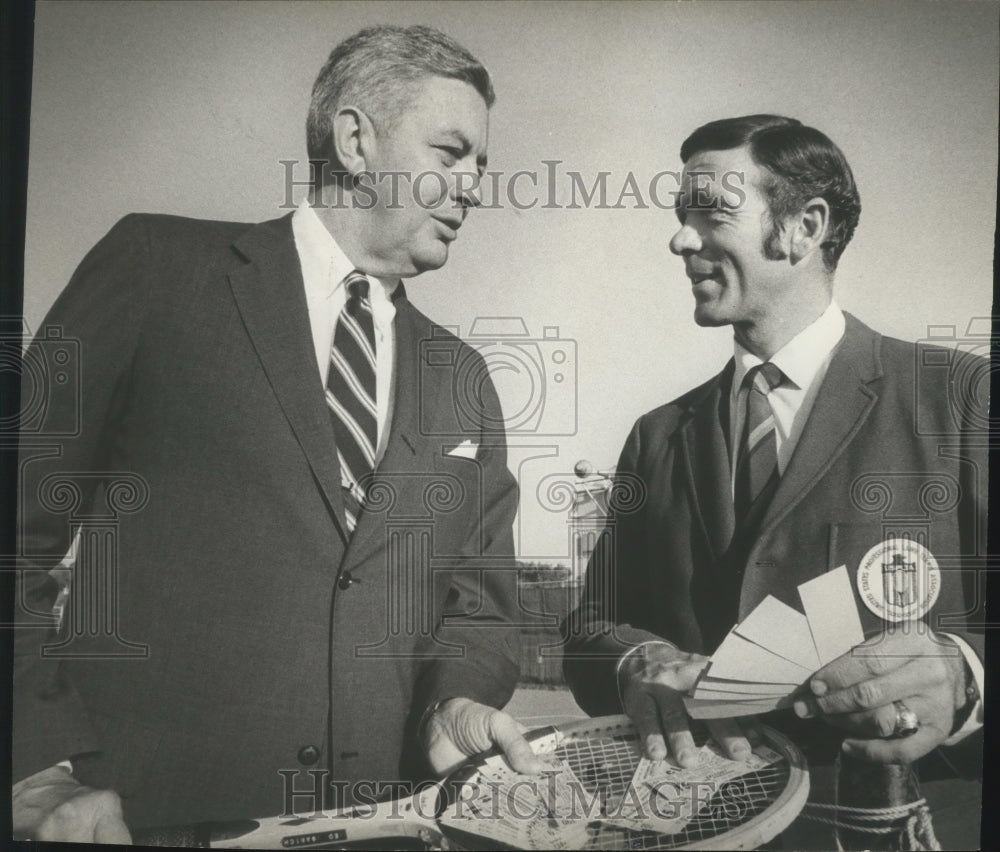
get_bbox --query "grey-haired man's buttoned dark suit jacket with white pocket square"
[14,215,518,826]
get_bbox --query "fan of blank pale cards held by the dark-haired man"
[684,565,864,719]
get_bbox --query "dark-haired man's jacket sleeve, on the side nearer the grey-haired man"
[563,419,663,716]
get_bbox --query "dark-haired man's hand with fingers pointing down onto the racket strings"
[618,642,760,767]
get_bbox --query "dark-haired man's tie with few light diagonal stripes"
[733,362,785,526]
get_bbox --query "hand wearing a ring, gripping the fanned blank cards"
[795,625,966,763]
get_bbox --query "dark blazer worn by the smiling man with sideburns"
[565,315,989,744]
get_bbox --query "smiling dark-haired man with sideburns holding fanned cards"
[565,115,988,844]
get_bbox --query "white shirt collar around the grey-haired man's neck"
[292,198,402,308]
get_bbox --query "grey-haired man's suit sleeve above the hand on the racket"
[411,356,520,720]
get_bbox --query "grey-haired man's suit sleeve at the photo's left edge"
[12,216,148,779]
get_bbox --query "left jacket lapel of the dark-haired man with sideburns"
[681,361,735,558]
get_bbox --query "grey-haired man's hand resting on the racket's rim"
[423,698,549,776]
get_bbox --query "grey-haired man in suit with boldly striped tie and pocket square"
[13,26,538,842]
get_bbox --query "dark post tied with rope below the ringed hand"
[837,754,920,849]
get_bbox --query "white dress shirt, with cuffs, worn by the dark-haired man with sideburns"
[618,300,985,745]
